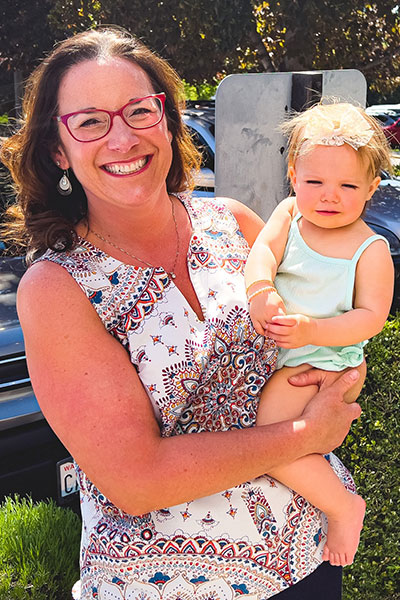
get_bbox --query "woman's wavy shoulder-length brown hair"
[0,27,200,258]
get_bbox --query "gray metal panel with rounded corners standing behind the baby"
[215,69,367,219]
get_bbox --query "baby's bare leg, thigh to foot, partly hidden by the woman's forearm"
[257,365,365,565]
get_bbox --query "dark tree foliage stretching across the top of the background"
[0,0,400,91]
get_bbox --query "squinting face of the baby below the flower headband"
[289,144,380,229]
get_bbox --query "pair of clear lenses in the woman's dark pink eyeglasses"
[68,97,163,142]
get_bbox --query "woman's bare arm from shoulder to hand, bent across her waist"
[18,262,360,515]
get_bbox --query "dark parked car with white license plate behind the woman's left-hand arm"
[0,257,79,511]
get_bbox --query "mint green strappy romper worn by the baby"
[275,213,389,371]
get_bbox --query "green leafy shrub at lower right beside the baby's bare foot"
[337,314,400,600]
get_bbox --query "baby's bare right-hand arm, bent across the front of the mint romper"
[267,240,394,348]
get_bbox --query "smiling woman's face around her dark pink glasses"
[53,58,172,216]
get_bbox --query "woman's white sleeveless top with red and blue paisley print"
[42,195,352,600]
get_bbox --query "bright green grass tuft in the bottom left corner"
[0,497,81,600]
